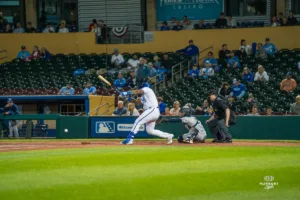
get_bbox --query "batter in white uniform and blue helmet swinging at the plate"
[121,83,174,145]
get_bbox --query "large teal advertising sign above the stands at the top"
[156,0,224,21]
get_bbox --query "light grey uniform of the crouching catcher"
[181,116,206,142]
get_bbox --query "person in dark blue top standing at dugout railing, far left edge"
[0,98,19,138]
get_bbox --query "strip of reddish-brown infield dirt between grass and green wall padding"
[0,140,300,152]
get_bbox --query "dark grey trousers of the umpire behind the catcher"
[207,118,231,140]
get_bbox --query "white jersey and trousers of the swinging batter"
[131,87,170,138]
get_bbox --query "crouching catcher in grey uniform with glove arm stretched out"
[156,106,206,144]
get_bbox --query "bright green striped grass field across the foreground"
[0,145,300,200]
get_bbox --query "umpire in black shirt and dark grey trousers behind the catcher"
[206,91,236,143]
